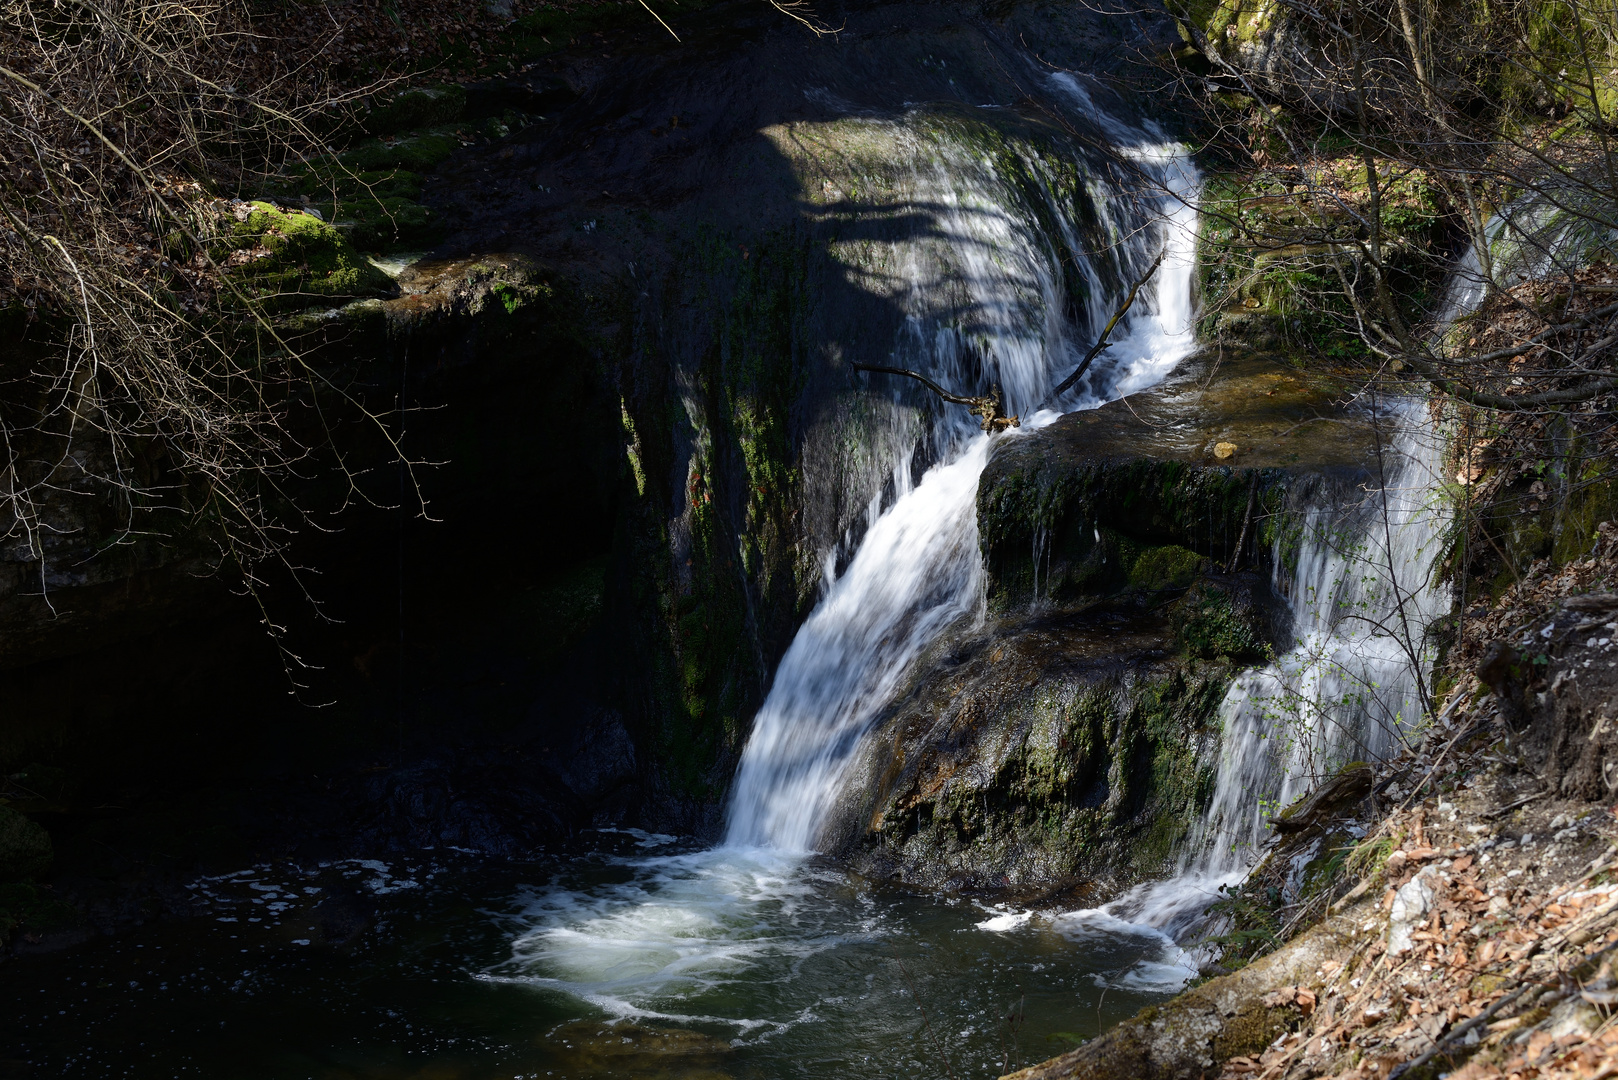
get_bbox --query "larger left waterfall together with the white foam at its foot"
[487,74,1199,1062]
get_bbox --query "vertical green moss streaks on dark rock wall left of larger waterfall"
[621,230,812,800]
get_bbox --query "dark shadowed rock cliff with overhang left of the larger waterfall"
[0,3,1173,906]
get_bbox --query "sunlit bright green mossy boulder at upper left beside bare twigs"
[225,201,398,309]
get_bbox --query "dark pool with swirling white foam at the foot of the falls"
[0,834,1191,1080]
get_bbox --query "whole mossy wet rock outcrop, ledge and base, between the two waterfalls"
[822,355,1379,899]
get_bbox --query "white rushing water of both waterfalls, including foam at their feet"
[498,76,1446,1016]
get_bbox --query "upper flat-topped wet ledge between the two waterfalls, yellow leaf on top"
[977,351,1388,615]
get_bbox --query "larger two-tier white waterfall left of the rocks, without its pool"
[726,82,1199,852]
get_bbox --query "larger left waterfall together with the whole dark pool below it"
[0,76,1199,1080]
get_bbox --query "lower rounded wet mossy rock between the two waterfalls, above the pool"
[822,604,1230,899]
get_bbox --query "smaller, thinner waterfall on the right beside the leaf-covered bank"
[1060,402,1450,941]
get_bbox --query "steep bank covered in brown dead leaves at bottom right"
[1013,615,1618,1080]
